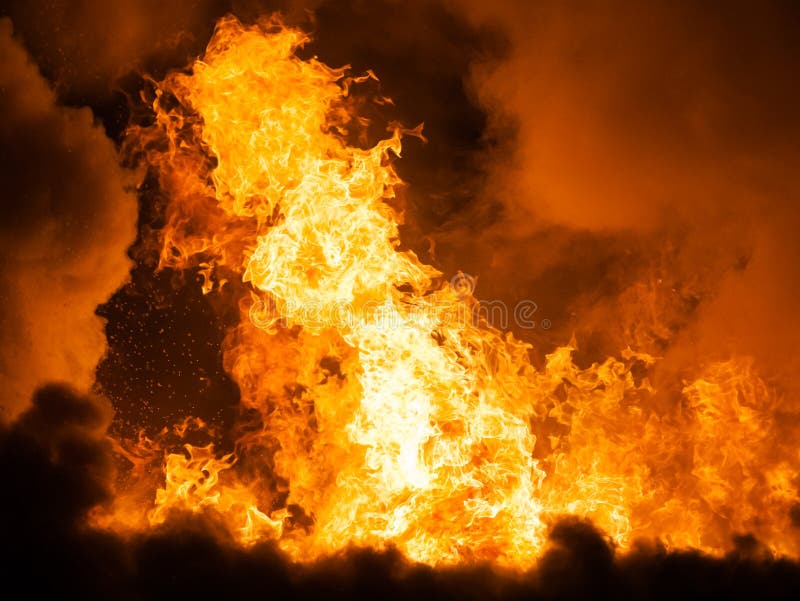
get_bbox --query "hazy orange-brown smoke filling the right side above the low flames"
[439,0,800,392]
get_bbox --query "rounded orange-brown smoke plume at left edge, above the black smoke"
[0,19,136,417]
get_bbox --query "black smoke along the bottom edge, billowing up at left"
[0,385,800,601]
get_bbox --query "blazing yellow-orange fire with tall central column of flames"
[97,17,798,569]
